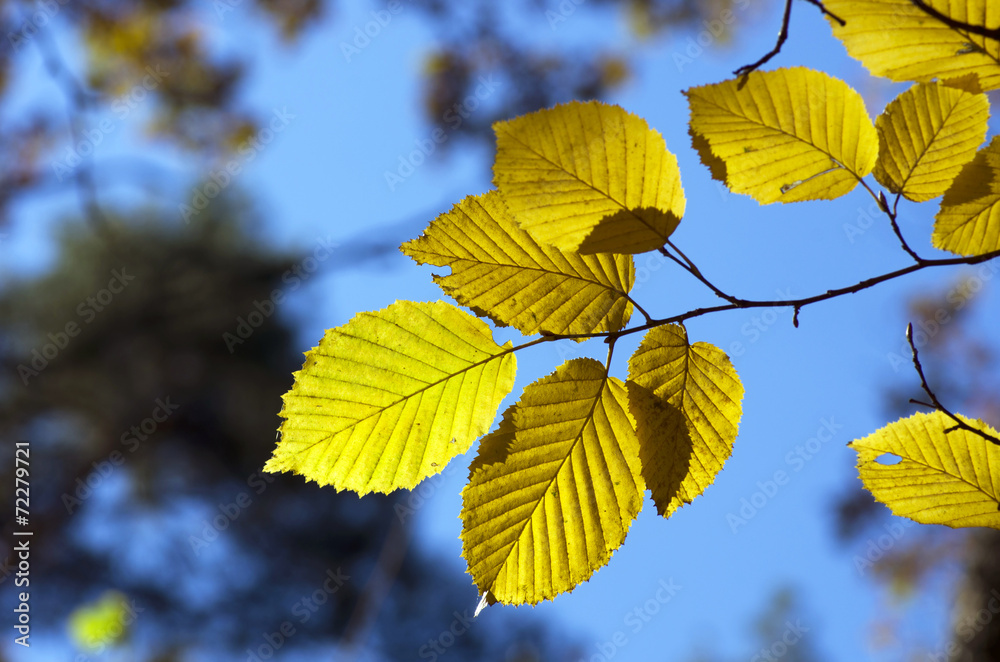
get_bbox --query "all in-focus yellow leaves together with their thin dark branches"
[265,0,1000,604]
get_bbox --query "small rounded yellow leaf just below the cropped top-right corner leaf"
[874,83,990,202]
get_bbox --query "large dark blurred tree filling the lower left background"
[0,203,592,660]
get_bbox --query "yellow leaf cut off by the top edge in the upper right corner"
[825,0,1000,90]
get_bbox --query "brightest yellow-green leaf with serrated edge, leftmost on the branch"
[264,301,516,494]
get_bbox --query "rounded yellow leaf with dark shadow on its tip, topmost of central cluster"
[493,101,685,254]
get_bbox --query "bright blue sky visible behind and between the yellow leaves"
[4,0,998,660]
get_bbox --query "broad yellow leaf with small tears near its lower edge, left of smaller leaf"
[685,67,878,204]
